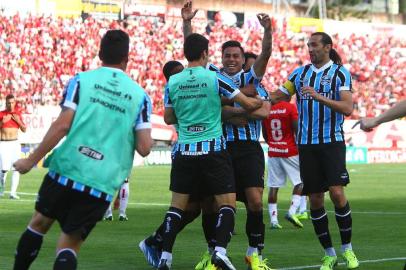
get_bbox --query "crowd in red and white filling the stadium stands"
[0,15,406,117]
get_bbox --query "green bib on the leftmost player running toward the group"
[48,67,145,196]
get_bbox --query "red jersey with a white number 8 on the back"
[263,101,298,157]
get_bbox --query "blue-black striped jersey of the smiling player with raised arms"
[208,64,268,142]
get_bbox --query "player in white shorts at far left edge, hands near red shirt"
[0,94,27,199]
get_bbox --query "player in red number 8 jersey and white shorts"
[262,98,306,229]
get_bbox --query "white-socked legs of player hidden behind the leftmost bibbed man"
[103,177,130,221]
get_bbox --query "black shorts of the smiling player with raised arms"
[227,141,265,202]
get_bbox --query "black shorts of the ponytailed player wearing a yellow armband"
[298,142,350,194]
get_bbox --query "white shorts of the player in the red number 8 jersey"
[268,155,302,188]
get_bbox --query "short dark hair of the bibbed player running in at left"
[99,30,130,65]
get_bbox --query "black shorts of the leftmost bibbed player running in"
[35,174,110,240]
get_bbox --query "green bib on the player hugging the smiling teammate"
[168,67,222,143]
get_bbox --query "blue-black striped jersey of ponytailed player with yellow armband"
[279,61,352,145]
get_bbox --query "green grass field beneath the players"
[0,164,406,270]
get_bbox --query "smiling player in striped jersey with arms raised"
[182,1,272,270]
